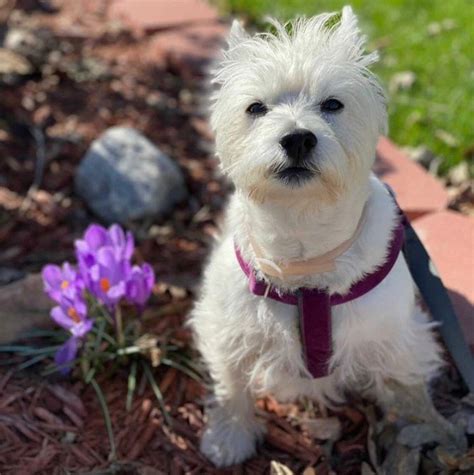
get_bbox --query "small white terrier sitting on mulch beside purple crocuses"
[190,7,441,466]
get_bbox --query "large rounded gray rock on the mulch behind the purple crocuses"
[75,127,187,224]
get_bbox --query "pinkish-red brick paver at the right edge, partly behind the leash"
[413,211,474,351]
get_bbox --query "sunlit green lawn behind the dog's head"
[217,0,474,173]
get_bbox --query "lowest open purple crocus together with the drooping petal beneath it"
[51,295,93,374]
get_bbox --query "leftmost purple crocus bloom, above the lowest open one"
[41,262,84,303]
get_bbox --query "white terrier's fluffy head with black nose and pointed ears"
[211,7,387,200]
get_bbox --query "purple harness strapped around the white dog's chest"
[235,215,404,378]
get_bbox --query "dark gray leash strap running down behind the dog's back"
[403,219,474,393]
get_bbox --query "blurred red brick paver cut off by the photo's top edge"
[108,0,218,32]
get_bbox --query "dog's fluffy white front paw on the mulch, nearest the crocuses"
[201,419,265,467]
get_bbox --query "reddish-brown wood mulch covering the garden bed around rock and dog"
[0,0,472,475]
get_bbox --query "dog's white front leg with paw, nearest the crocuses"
[201,361,264,467]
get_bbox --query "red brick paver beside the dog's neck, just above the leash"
[374,137,448,219]
